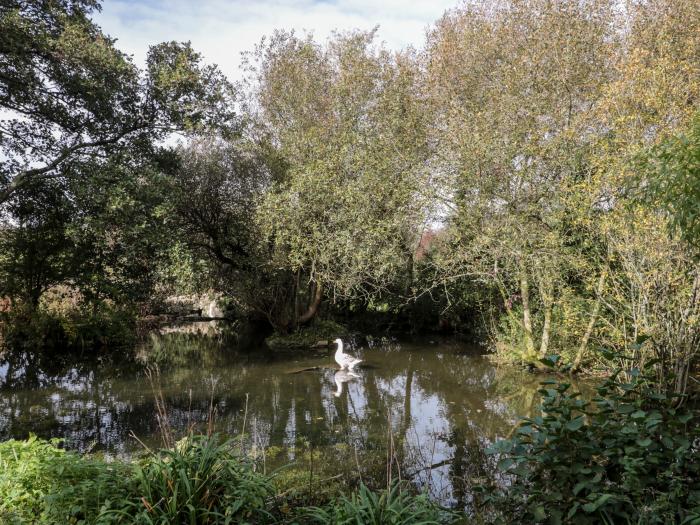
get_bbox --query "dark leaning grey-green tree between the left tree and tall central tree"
[172,136,292,329]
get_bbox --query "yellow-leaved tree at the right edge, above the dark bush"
[594,0,700,384]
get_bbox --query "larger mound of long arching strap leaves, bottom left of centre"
[103,436,273,524]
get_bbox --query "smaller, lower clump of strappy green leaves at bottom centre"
[306,484,456,525]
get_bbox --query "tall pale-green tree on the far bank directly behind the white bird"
[249,28,428,325]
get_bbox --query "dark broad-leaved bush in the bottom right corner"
[482,358,700,525]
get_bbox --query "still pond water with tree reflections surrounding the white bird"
[0,328,552,507]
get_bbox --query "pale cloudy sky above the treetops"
[94,0,457,80]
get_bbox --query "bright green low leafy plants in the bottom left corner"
[0,436,131,525]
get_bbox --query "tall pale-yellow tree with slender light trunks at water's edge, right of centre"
[425,0,611,361]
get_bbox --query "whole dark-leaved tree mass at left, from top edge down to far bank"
[0,0,237,312]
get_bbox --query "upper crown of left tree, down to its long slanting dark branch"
[0,0,234,204]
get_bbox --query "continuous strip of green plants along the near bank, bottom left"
[0,436,457,525]
